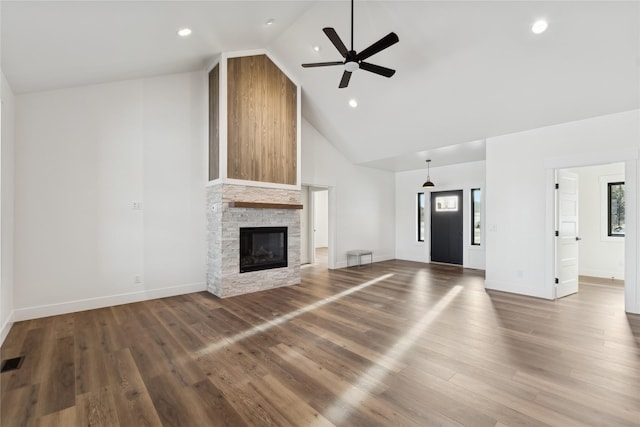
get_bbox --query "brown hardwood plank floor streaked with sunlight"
[0,261,640,427]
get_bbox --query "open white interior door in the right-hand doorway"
[556,170,580,298]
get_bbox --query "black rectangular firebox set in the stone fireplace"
[240,227,287,273]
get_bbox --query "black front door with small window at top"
[431,190,463,265]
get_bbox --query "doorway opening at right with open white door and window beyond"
[554,162,629,306]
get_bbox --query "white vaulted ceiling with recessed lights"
[0,0,640,171]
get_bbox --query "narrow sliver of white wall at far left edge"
[0,70,15,344]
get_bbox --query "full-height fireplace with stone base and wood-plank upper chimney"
[206,51,302,298]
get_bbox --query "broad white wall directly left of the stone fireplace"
[14,72,207,320]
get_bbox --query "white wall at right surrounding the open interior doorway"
[485,110,640,312]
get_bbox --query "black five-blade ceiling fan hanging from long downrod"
[302,0,400,88]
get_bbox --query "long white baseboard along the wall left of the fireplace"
[14,282,207,322]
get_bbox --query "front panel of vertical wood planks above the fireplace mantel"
[227,55,297,185]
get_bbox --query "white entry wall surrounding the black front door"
[396,161,485,269]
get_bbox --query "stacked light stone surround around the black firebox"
[207,184,300,298]
